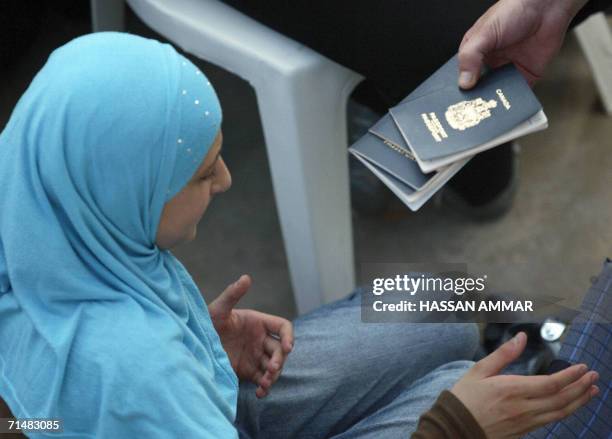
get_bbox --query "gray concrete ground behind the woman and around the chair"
[0,6,612,317]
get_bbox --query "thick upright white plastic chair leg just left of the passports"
[253,61,361,314]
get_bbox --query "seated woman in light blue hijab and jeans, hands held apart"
[0,33,597,438]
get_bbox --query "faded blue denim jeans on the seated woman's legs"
[236,291,479,439]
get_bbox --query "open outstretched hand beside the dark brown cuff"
[451,332,599,439]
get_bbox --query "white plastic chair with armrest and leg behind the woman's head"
[91,0,362,313]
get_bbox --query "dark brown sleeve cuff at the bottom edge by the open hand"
[411,390,487,439]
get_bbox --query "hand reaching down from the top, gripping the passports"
[459,0,587,89]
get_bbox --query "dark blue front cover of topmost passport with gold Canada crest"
[390,63,542,161]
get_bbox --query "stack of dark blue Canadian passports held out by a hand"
[349,55,548,211]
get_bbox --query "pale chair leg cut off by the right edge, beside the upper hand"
[575,12,612,115]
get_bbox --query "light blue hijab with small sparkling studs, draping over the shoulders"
[0,33,238,438]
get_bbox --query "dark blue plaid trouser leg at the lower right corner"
[526,260,612,439]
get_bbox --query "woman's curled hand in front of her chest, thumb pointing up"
[208,275,293,398]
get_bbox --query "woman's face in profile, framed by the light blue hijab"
[156,131,232,249]
